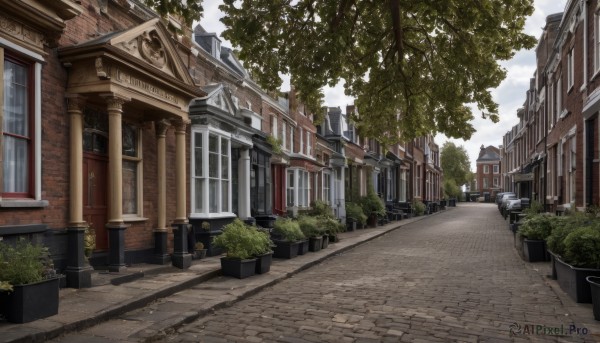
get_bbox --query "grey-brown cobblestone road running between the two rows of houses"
[163,203,600,343]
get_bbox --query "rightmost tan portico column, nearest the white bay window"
[172,121,192,269]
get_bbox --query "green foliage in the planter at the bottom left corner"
[0,239,52,288]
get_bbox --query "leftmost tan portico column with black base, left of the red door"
[65,95,92,288]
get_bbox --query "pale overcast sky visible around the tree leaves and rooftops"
[194,0,567,171]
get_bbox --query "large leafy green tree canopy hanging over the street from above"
[220,0,536,144]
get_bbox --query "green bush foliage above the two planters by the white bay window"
[213,218,273,259]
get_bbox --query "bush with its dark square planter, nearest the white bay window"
[213,218,258,279]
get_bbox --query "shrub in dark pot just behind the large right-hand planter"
[518,214,552,262]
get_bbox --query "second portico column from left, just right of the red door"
[106,95,126,272]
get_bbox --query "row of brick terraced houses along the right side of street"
[502,0,600,212]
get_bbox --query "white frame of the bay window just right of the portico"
[190,126,235,218]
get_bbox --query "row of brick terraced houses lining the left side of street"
[0,0,442,287]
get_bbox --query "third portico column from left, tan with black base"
[152,120,171,264]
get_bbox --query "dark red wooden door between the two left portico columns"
[83,153,108,250]
